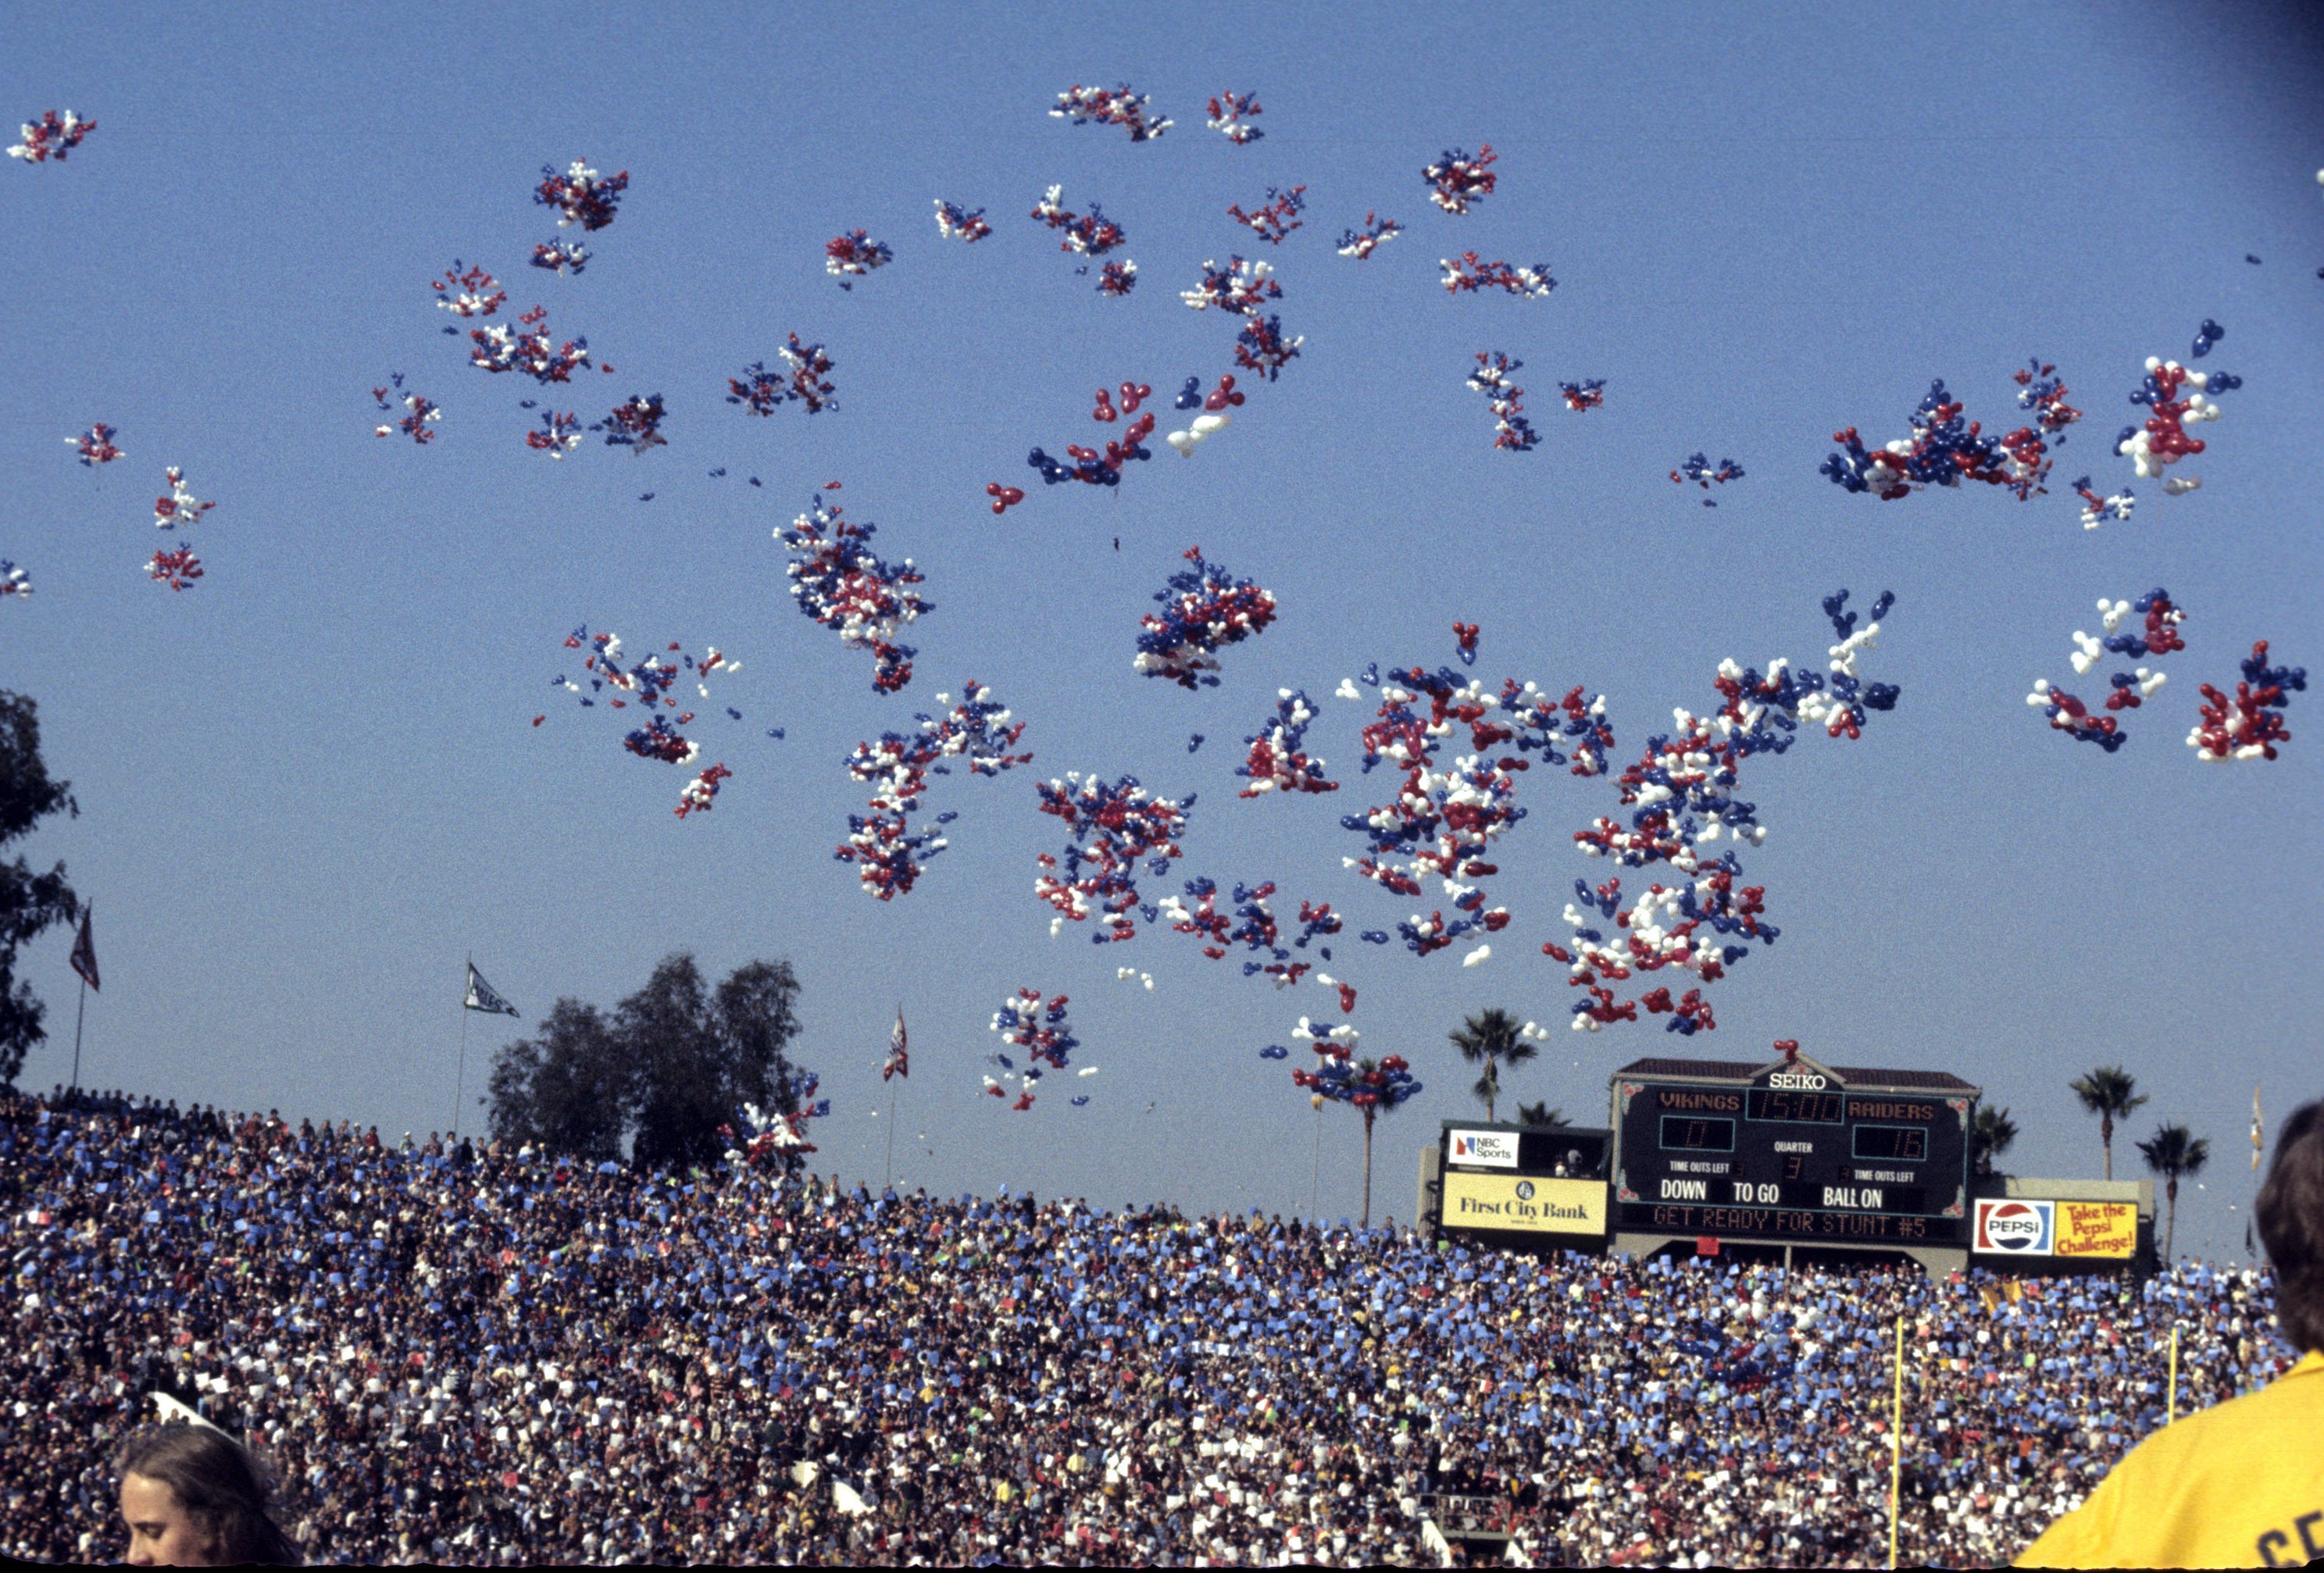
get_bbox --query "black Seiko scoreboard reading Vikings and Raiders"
[1613,1055,1978,1246]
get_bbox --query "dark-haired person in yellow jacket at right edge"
[2017,1101,2324,1568]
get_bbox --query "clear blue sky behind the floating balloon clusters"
[0,5,2324,1252]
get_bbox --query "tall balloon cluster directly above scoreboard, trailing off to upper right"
[1540,590,1897,1036]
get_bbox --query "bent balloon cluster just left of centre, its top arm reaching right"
[832,679,1032,901]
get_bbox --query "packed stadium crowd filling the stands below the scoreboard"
[0,1090,2289,1566]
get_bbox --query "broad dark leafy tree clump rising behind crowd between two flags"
[491,953,799,1168]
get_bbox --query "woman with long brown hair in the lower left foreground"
[116,1422,307,1568]
